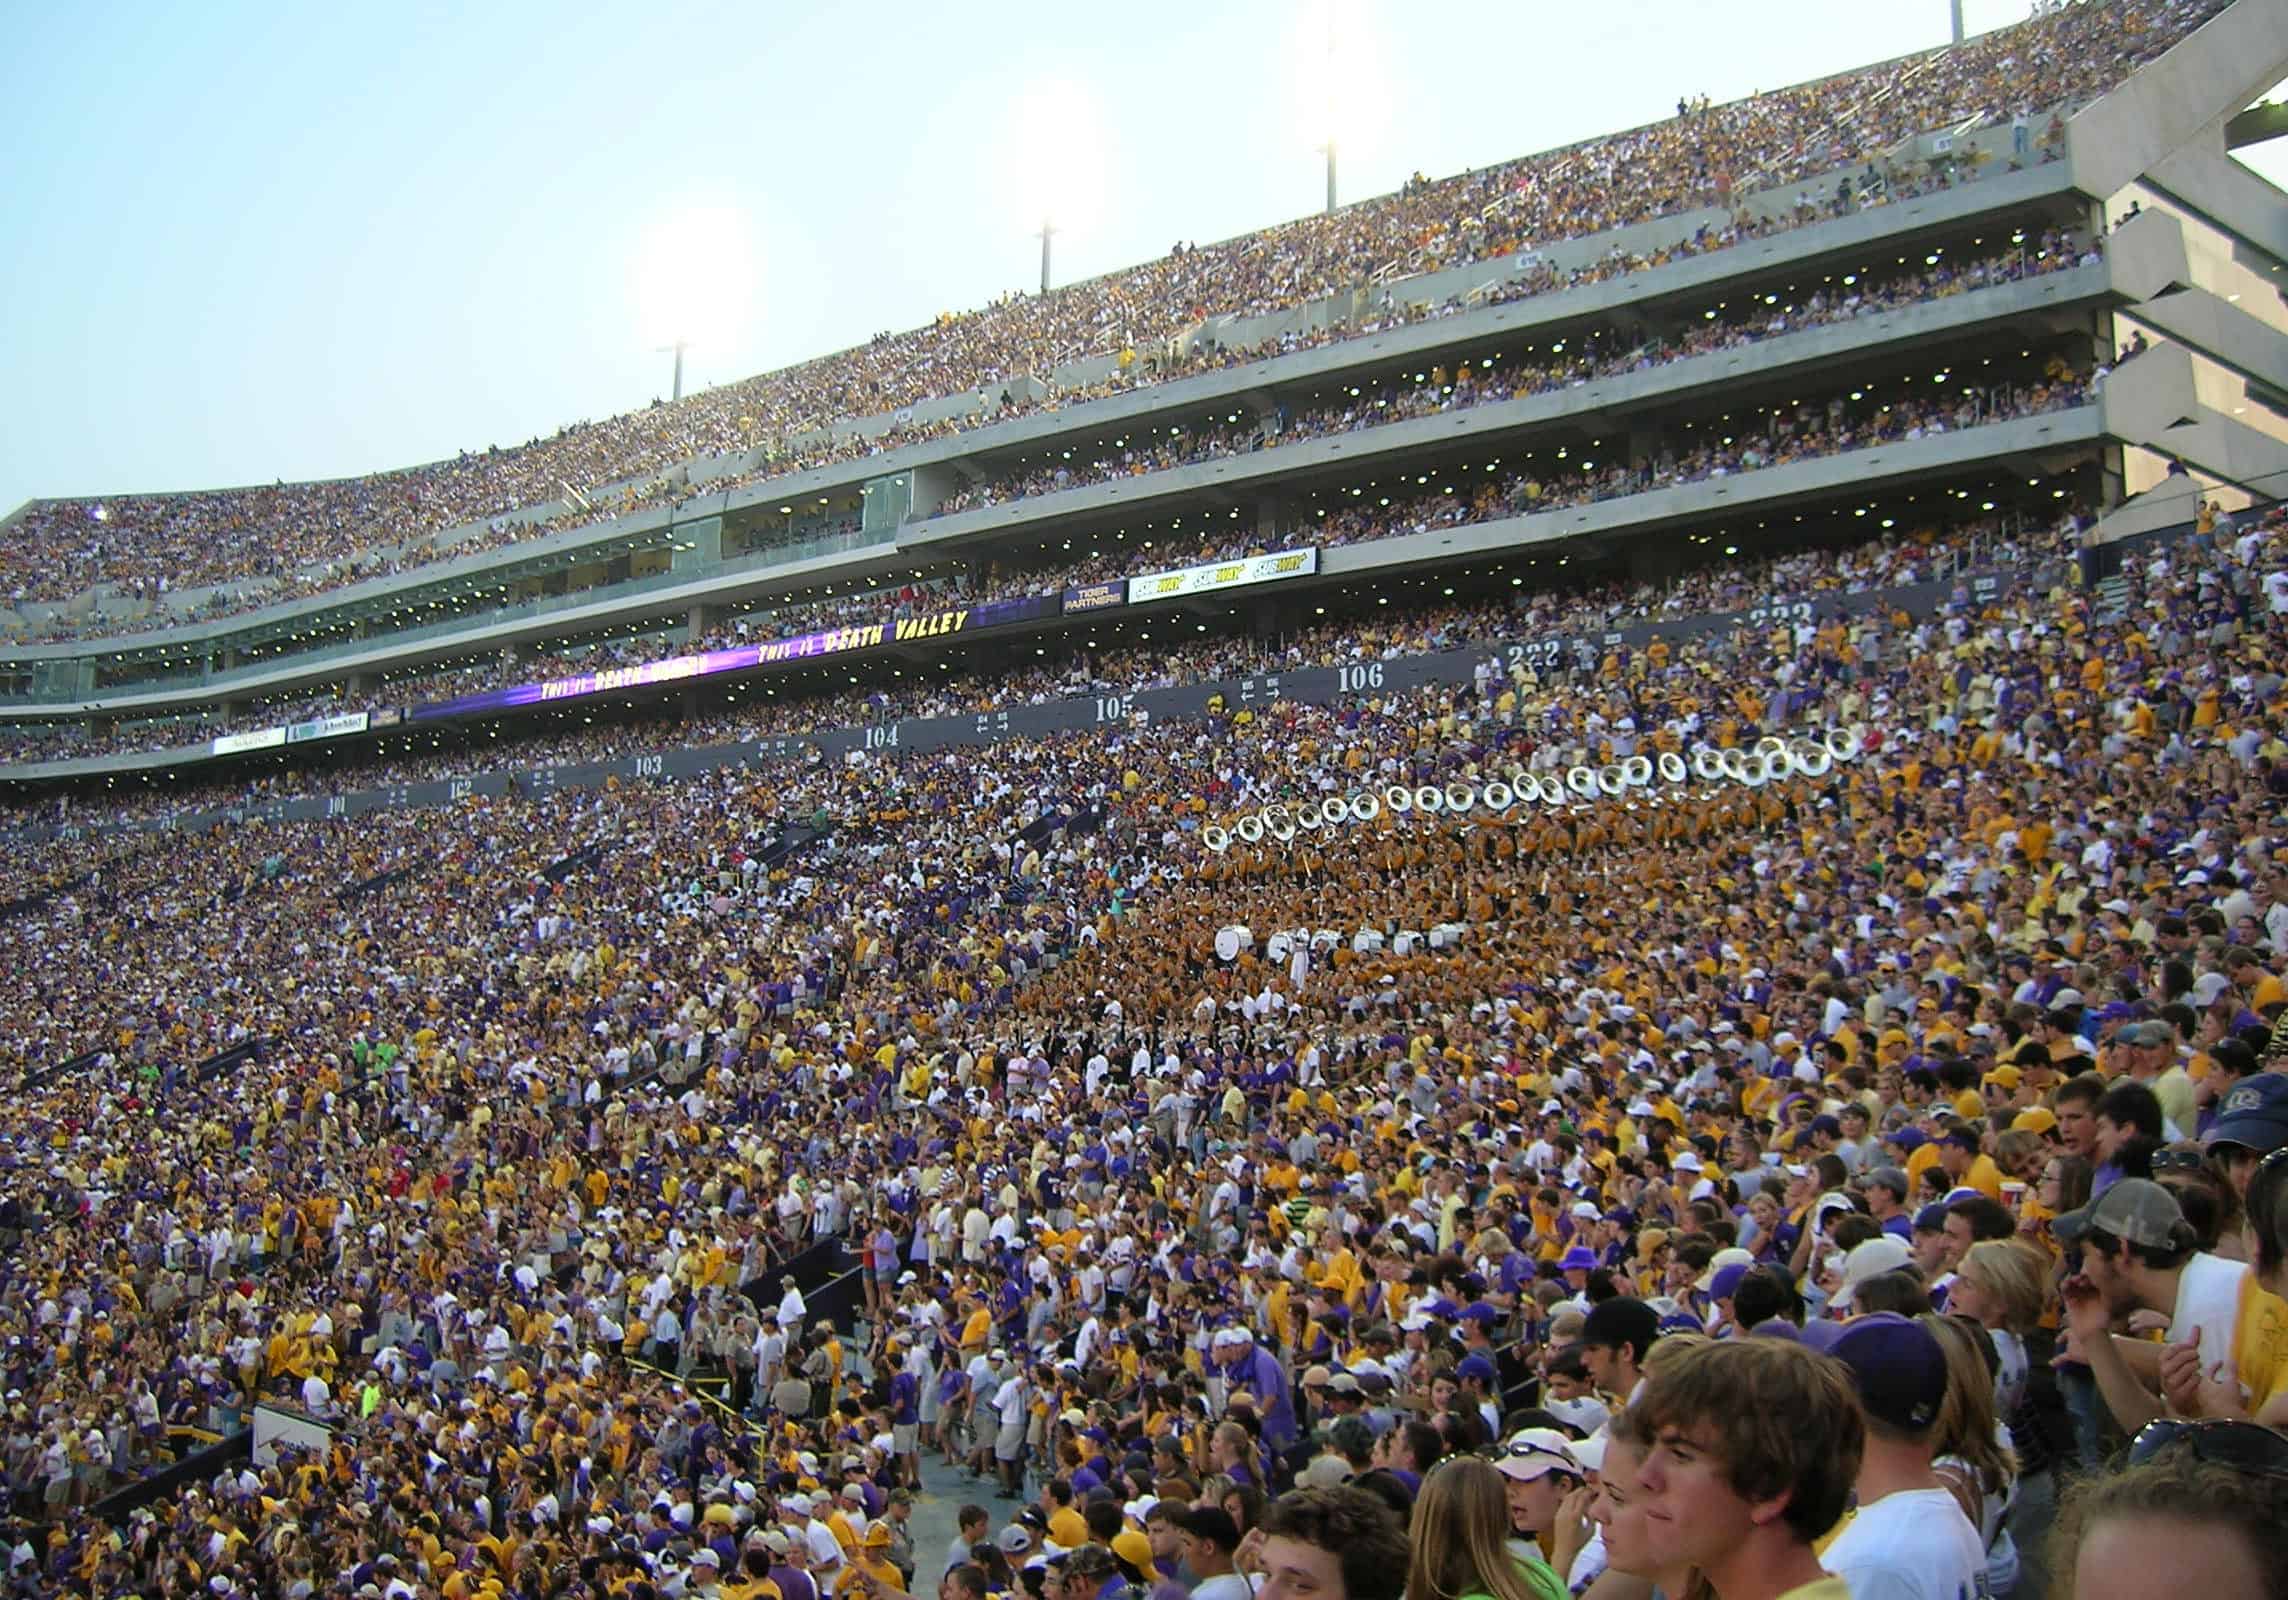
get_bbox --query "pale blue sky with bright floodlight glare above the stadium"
[0,0,2278,513]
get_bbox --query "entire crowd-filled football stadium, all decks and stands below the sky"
[0,0,2288,1600]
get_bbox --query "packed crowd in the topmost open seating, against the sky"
[0,0,2222,639]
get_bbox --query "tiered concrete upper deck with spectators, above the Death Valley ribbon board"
[0,0,2288,782]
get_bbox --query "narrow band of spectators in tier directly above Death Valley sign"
[0,334,2100,778]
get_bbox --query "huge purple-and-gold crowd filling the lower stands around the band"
[0,471,2288,1600]
